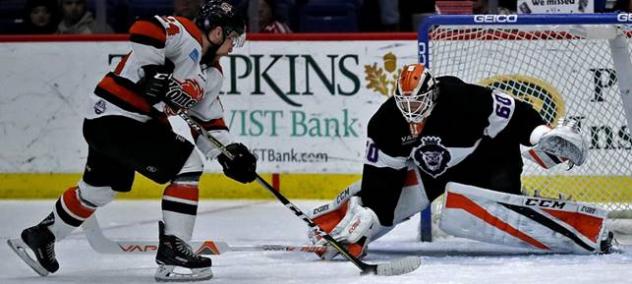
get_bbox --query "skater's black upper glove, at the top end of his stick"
[138,64,173,104]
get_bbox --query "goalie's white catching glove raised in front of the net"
[523,119,588,169]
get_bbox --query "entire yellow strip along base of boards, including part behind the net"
[0,173,632,203]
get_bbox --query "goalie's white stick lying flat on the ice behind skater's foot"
[82,216,327,255]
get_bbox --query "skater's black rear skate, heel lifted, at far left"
[7,220,59,276]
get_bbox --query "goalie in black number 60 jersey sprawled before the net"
[309,64,612,258]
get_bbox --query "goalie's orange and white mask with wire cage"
[394,64,438,123]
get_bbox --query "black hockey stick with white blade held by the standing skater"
[177,109,421,275]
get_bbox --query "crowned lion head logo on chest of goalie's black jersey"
[413,136,451,177]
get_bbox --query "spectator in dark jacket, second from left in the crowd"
[57,0,113,34]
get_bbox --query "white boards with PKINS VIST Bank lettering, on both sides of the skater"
[0,40,417,173]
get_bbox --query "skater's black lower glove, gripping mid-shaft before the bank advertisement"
[217,143,257,183]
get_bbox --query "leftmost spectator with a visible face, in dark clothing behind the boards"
[20,0,57,34]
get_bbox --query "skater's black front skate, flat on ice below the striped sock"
[154,222,213,282]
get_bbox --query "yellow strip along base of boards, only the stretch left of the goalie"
[0,173,360,199]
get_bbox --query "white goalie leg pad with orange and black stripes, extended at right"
[439,182,608,254]
